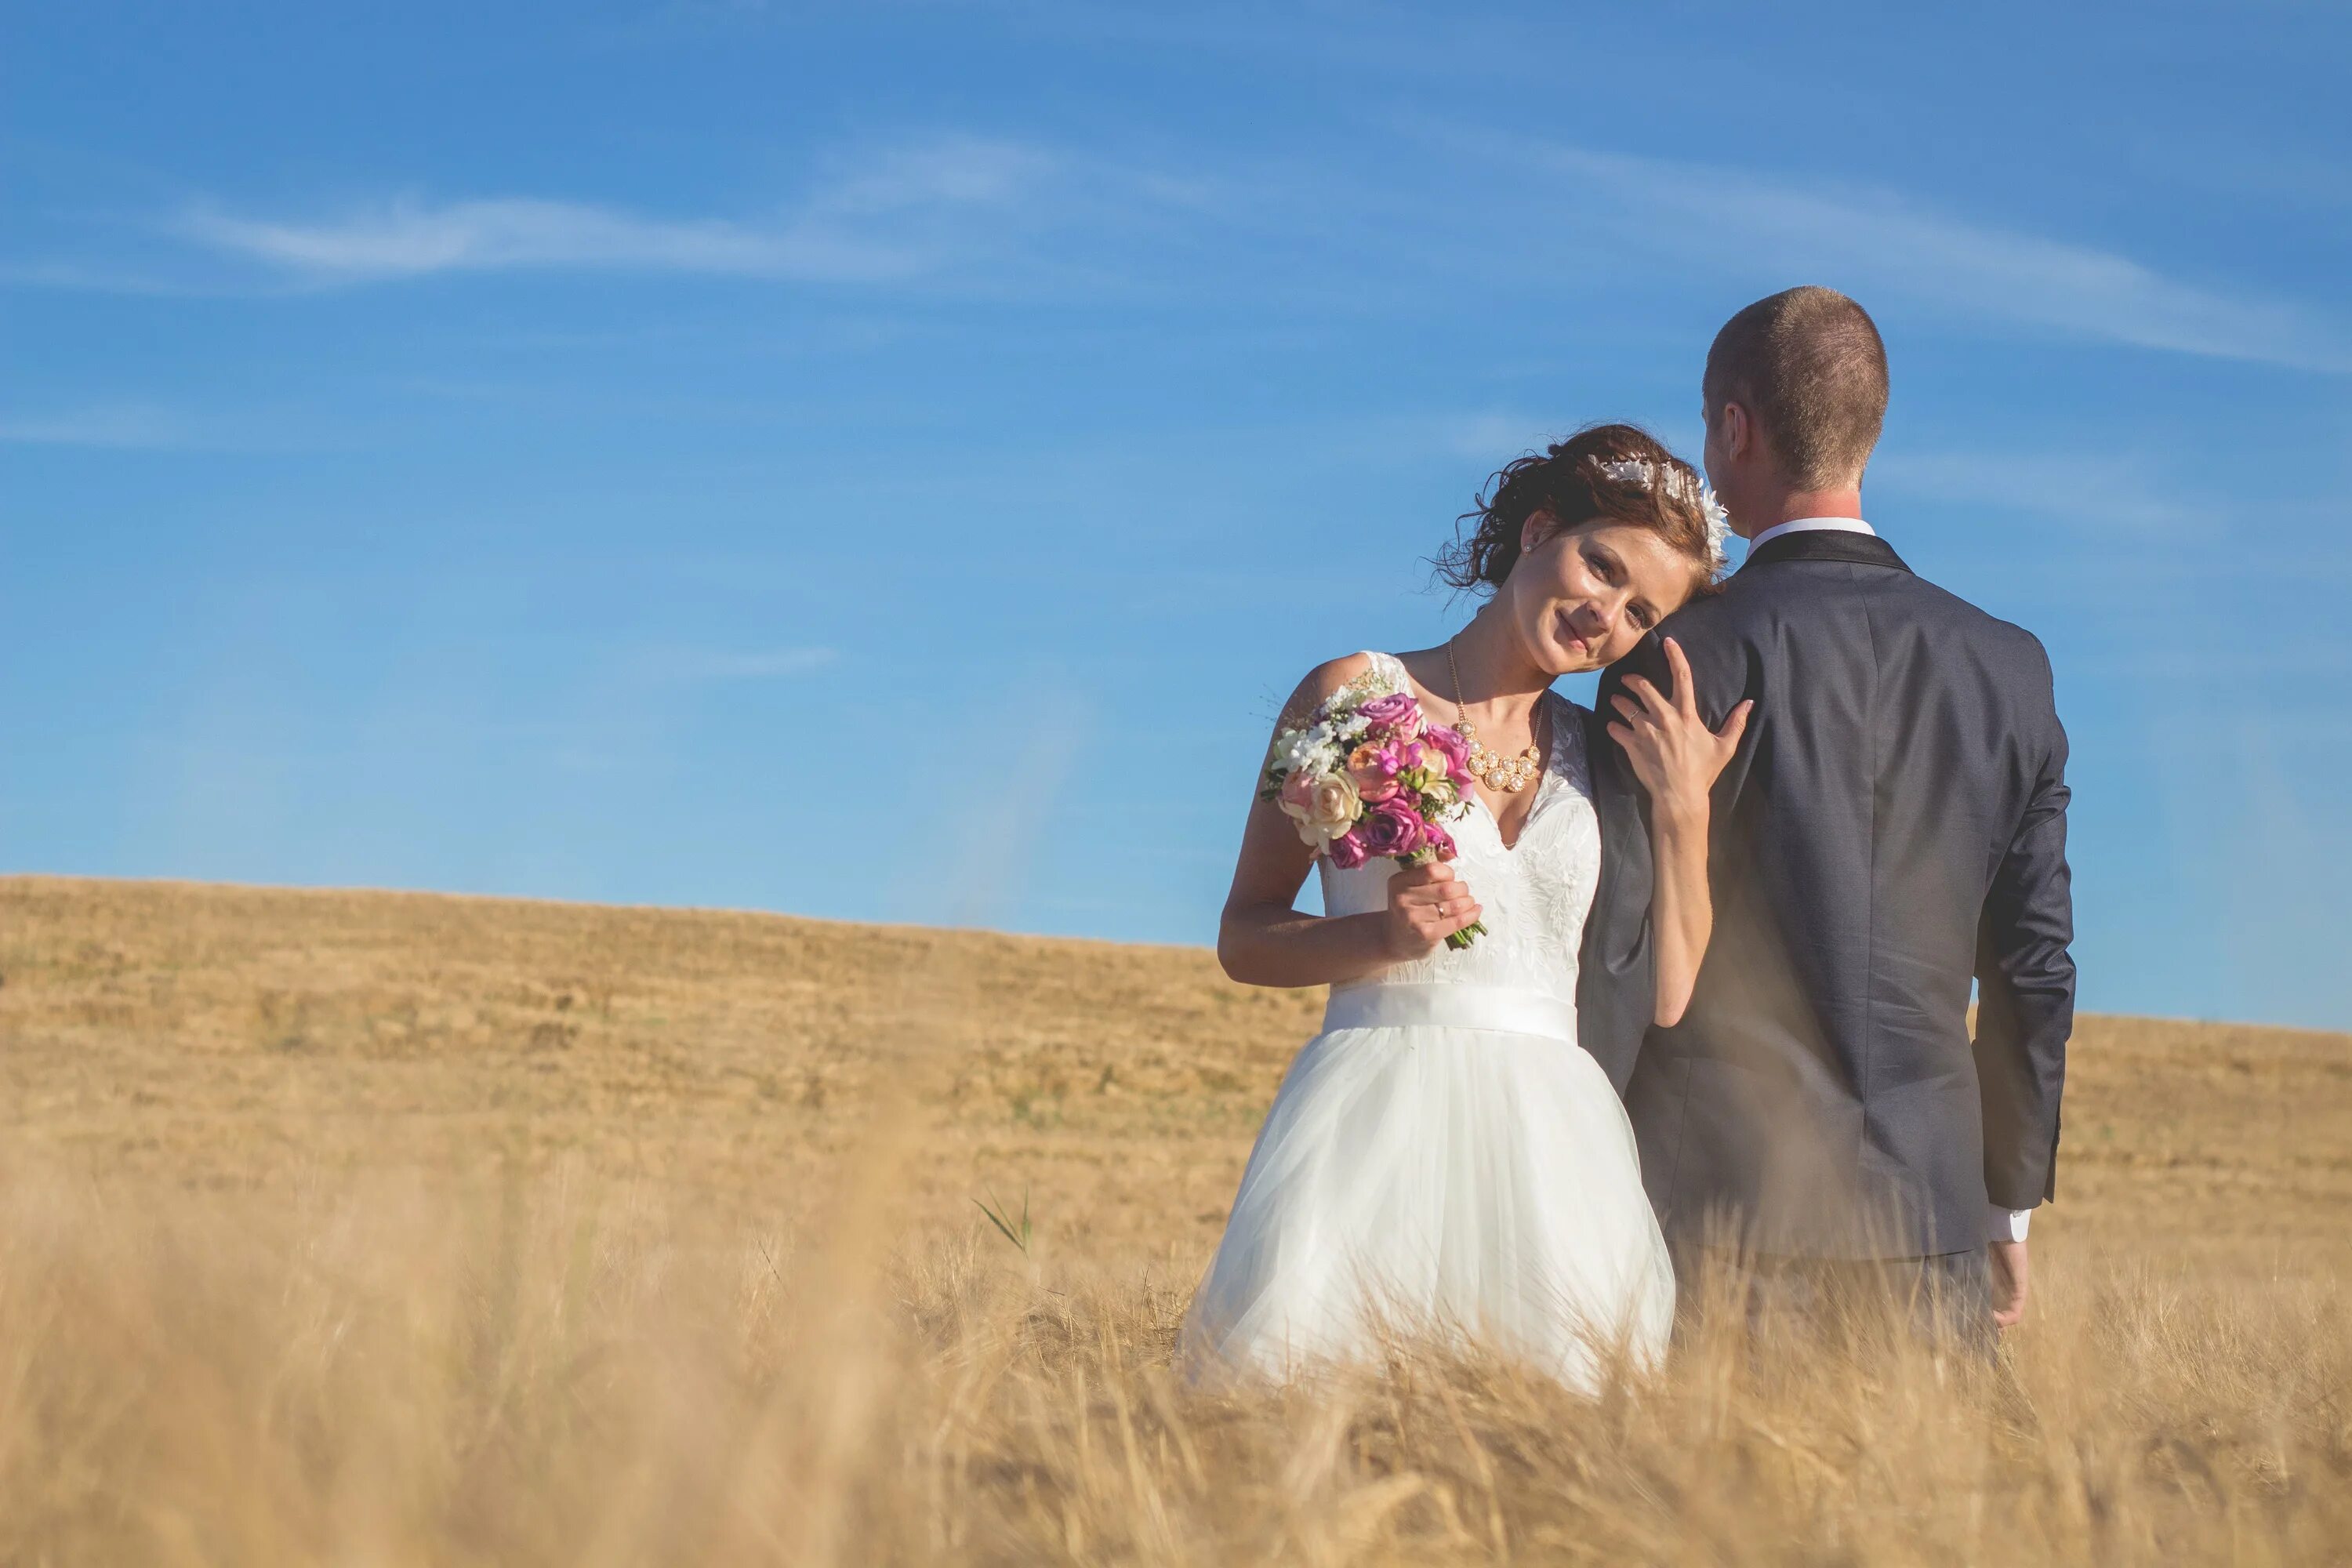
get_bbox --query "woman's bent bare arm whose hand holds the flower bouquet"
[1216,659,1479,985]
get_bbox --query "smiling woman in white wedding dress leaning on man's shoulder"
[1178,426,1748,1387]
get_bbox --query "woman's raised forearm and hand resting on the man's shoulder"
[1609,637,1755,1027]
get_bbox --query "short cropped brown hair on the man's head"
[1700,285,1886,489]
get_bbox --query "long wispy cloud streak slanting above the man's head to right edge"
[1494,141,2352,374]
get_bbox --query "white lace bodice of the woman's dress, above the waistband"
[1319,654,1602,1006]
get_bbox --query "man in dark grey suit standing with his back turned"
[1599,289,2074,1345]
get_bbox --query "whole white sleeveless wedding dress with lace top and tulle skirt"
[1178,654,1675,1389]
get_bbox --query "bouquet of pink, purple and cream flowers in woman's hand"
[1258,670,1486,947]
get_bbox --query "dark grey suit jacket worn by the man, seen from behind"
[1578,532,2074,1258]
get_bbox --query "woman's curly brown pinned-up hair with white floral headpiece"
[1437,426,1719,593]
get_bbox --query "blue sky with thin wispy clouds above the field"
[0,2,2352,1027]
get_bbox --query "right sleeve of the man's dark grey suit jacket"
[1976,661,2074,1210]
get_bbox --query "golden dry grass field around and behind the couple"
[0,877,2352,1566]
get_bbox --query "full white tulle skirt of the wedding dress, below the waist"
[1178,1025,1675,1389]
